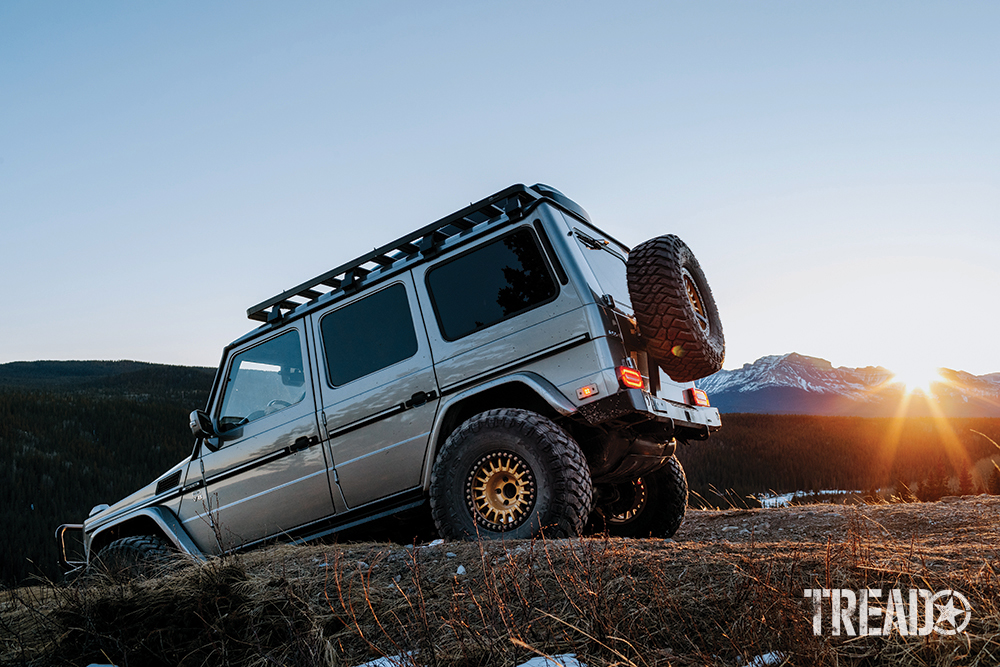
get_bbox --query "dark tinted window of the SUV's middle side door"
[320,284,417,387]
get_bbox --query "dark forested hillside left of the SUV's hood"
[0,362,214,584]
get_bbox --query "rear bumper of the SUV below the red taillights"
[579,389,722,440]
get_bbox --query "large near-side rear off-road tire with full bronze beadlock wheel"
[430,408,593,540]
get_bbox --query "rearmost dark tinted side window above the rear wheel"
[427,228,557,340]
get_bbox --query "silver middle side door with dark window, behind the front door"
[312,273,439,508]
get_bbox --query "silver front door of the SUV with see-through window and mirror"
[184,328,334,552]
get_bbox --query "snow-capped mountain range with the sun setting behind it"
[696,352,1000,417]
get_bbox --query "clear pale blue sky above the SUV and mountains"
[0,0,1000,375]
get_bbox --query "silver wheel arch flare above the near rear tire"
[421,372,576,492]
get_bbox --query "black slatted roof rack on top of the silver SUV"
[247,185,551,322]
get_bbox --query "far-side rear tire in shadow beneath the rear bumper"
[604,456,688,538]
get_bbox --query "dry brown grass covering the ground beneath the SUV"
[0,498,1000,667]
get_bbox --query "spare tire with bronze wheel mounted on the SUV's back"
[626,234,726,382]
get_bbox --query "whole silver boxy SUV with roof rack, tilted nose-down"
[57,185,724,568]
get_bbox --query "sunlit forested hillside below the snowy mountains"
[678,414,1000,506]
